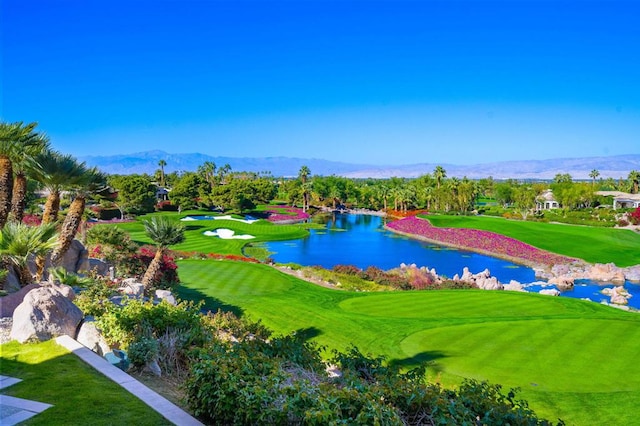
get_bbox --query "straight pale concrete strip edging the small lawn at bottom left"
[57,336,202,426]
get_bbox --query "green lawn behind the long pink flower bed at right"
[425,215,640,267]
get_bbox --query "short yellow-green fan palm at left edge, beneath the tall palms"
[0,222,58,287]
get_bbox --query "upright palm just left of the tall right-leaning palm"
[35,151,87,223]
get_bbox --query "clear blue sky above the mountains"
[0,0,640,165]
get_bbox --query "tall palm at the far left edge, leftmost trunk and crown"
[0,121,44,229]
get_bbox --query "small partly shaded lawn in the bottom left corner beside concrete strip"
[0,340,171,425]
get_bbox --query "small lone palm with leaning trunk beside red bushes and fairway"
[142,216,184,288]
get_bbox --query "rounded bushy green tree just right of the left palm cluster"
[108,175,156,214]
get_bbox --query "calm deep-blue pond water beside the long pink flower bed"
[264,214,640,309]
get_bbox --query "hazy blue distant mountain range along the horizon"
[80,150,640,179]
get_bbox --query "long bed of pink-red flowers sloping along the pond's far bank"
[387,216,575,265]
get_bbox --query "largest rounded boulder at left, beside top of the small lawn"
[11,286,83,343]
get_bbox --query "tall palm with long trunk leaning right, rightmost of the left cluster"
[51,167,108,266]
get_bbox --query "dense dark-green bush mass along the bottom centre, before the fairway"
[186,336,562,425]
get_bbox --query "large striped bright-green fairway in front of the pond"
[179,260,640,425]
